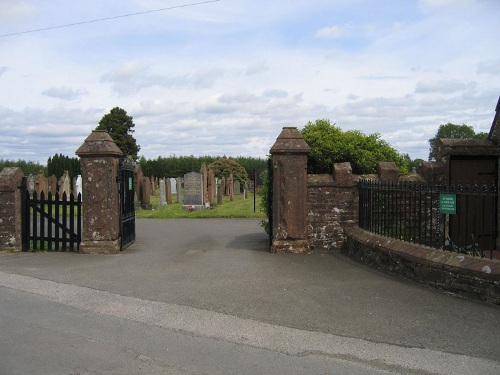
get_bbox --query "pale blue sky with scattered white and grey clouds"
[0,0,500,164]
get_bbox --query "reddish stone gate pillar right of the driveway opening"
[271,127,311,253]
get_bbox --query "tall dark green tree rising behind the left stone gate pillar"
[96,107,141,160]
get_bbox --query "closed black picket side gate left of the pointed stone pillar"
[21,177,82,252]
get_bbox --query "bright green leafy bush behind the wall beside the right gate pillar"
[301,119,408,174]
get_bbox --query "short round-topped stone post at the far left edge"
[0,167,24,251]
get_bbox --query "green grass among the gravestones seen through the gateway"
[135,192,265,219]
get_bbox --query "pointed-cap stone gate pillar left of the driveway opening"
[76,130,123,254]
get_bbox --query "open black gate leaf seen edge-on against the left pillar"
[118,159,135,250]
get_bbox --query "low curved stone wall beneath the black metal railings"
[343,227,500,304]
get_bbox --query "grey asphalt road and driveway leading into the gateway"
[0,219,500,374]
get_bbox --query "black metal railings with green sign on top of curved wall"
[358,180,499,259]
